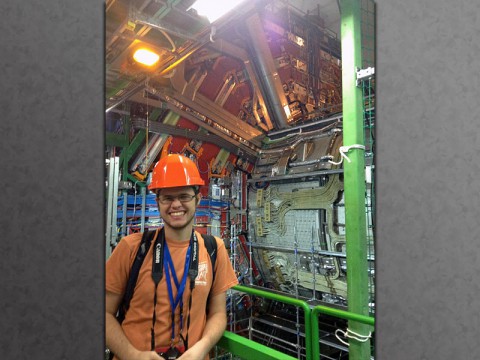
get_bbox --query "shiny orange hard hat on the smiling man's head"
[148,154,205,190]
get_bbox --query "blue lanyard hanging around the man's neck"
[164,242,190,342]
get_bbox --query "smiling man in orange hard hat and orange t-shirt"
[105,154,238,360]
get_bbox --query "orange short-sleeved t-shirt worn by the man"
[105,231,238,358]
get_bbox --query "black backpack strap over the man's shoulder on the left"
[117,230,158,324]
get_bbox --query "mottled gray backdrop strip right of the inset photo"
[376,0,480,360]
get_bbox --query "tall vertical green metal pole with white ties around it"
[340,0,371,360]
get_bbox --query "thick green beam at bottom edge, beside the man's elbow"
[217,331,296,360]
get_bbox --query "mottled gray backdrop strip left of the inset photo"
[0,0,105,360]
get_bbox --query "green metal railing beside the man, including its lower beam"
[217,285,375,360]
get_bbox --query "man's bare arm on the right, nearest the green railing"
[179,292,227,360]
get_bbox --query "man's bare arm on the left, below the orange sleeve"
[105,291,163,360]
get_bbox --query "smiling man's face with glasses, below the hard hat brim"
[157,186,201,230]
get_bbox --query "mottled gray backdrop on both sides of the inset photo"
[0,0,480,360]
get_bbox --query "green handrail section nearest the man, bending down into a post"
[232,285,318,360]
